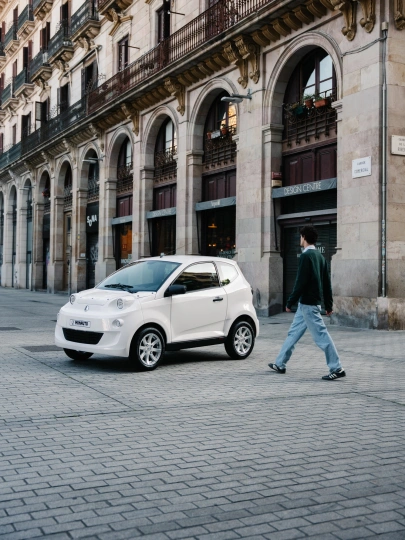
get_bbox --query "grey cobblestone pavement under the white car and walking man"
[0,289,405,540]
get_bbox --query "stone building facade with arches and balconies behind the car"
[0,0,405,329]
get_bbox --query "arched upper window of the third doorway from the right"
[154,118,177,182]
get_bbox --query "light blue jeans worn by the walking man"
[276,304,342,372]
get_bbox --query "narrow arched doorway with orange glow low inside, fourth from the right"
[113,137,133,269]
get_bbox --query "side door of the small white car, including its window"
[170,262,227,342]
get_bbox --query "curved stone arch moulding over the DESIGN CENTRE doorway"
[263,31,343,125]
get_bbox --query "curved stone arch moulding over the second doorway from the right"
[187,77,240,152]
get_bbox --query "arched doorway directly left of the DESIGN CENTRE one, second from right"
[197,92,237,258]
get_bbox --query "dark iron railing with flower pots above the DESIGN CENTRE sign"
[283,90,337,146]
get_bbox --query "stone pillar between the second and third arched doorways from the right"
[183,150,204,255]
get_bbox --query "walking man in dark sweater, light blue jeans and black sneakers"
[269,225,346,381]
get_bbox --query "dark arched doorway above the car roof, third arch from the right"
[148,118,177,256]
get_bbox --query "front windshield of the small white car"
[96,260,180,293]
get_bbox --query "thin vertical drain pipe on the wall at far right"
[381,22,388,298]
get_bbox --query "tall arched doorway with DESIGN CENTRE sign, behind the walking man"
[273,47,337,305]
